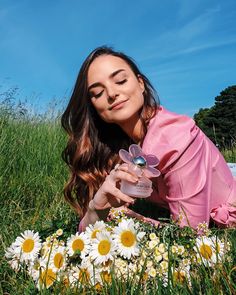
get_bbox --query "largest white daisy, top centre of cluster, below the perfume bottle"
[113,219,145,259]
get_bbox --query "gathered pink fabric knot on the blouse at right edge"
[210,204,236,227]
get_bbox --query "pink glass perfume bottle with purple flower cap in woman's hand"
[119,144,160,198]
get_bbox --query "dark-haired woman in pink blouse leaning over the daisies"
[62,47,236,231]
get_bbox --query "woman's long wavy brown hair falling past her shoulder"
[61,46,159,216]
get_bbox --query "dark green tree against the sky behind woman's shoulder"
[194,85,236,149]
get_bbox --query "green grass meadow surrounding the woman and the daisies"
[0,98,236,294]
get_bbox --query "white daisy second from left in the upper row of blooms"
[67,232,90,257]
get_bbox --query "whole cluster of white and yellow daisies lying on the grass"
[5,211,233,291]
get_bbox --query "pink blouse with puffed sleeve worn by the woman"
[142,106,236,228]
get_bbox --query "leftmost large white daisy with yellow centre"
[13,230,41,262]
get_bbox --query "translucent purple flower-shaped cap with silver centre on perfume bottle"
[119,144,161,177]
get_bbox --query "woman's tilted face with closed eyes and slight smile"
[87,55,145,127]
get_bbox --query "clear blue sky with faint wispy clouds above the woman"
[0,0,236,116]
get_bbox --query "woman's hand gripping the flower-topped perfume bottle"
[89,164,138,210]
